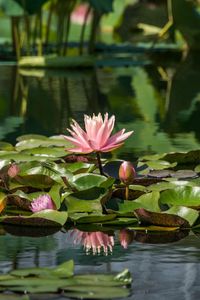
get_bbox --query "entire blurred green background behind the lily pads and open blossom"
[0,0,200,158]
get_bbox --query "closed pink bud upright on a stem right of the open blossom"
[119,161,136,185]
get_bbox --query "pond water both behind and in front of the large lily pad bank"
[0,54,200,300]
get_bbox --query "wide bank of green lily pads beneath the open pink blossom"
[0,131,200,231]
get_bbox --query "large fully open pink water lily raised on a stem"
[64,113,133,153]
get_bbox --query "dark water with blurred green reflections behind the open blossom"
[0,53,200,157]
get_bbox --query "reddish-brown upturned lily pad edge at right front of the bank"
[135,208,190,228]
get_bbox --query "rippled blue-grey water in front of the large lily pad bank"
[0,231,200,300]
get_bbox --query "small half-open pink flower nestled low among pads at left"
[30,194,55,212]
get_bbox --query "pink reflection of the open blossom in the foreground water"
[72,229,114,255]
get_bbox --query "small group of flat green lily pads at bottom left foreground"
[0,260,132,300]
